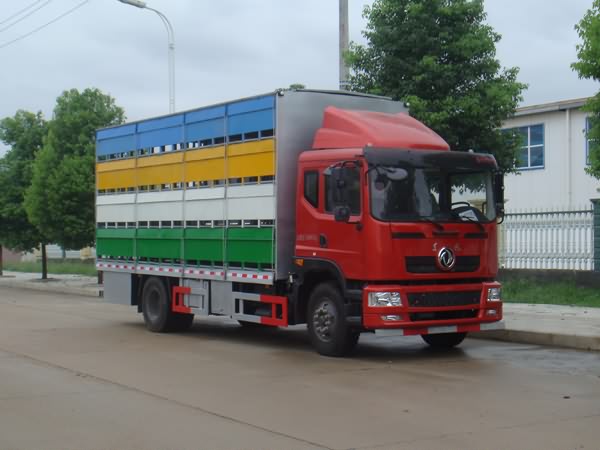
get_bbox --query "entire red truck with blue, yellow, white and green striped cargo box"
[96,90,502,356]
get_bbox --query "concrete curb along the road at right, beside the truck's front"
[469,330,600,351]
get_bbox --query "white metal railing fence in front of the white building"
[498,206,594,270]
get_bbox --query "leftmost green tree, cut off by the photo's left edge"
[0,110,48,279]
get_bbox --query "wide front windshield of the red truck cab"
[369,164,496,223]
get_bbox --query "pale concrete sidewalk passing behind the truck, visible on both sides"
[0,271,600,351]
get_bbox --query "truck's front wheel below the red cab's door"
[307,283,359,357]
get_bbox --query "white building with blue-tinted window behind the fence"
[503,98,600,212]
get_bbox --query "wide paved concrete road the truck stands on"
[0,288,600,449]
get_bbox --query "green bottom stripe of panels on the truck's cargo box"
[96,228,274,264]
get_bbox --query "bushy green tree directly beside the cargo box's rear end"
[25,89,125,249]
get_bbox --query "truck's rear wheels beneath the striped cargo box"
[142,277,194,333]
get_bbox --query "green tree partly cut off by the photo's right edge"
[571,0,600,178]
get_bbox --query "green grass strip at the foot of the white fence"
[502,279,600,308]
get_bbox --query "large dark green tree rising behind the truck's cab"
[346,0,526,171]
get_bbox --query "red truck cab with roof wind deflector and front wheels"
[293,107,503,355]
